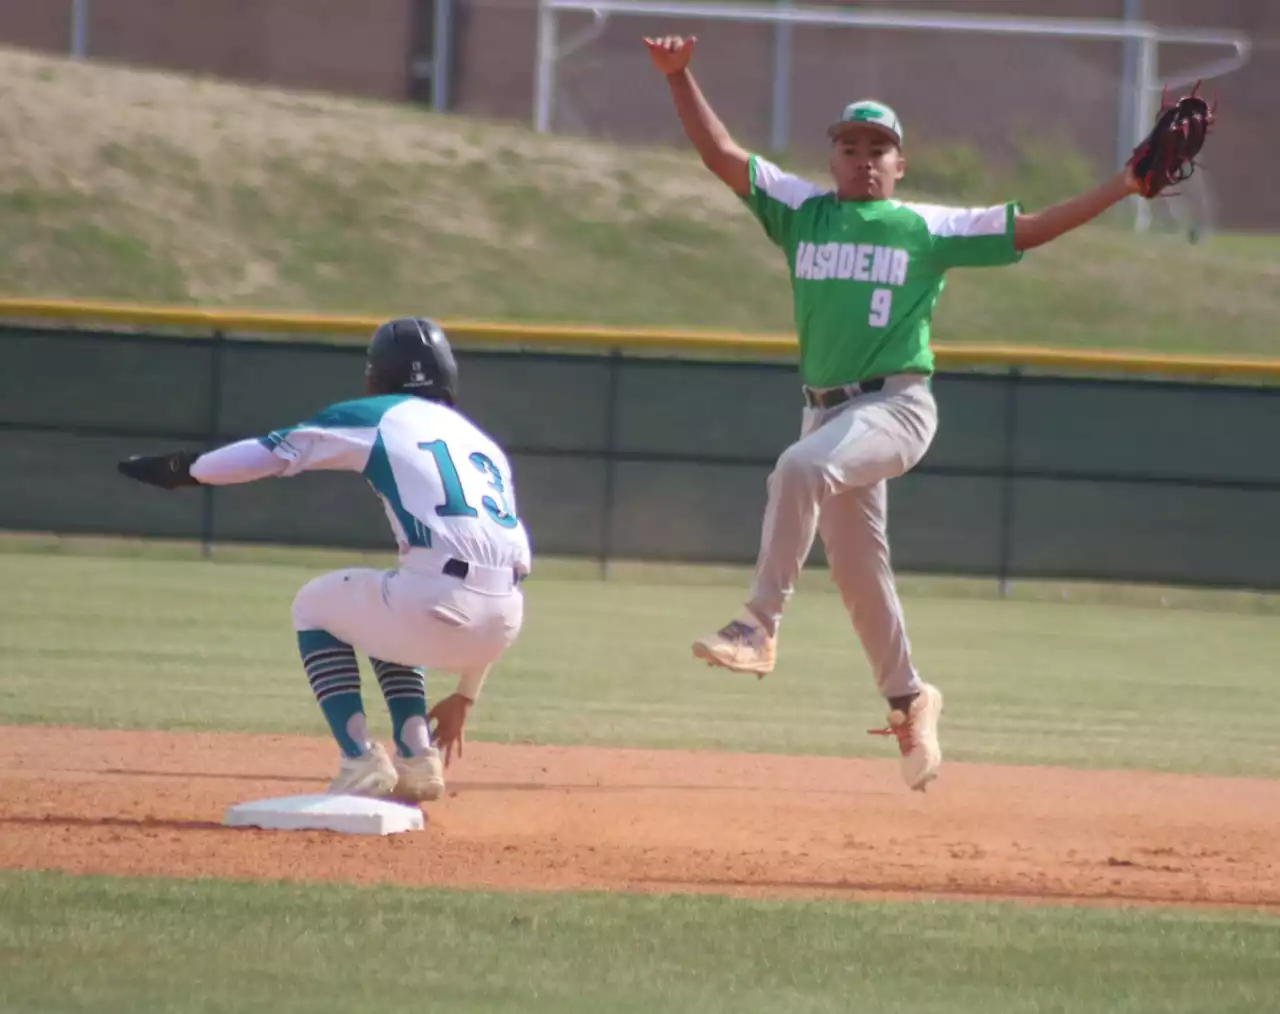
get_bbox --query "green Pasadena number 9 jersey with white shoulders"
[742,155,1021,388]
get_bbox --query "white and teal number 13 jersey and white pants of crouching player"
[191,394,531,700]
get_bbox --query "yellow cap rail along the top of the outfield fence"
[0,297,1280,382]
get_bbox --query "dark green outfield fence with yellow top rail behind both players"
[0,300,1280,589]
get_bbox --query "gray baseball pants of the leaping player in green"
[748,374,938,698]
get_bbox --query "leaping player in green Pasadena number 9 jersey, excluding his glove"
[644,36,1139,790]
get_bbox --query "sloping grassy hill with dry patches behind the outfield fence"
[0,50,1280,355]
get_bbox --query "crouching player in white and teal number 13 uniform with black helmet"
[119,318,531,801]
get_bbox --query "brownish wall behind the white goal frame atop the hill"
[0,0,1280,228]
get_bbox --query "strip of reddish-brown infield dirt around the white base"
[0,727,1280,909]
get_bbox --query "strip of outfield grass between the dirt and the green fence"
[0,553,1280,776]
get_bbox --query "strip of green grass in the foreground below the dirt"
[0,873,1280,1014]
